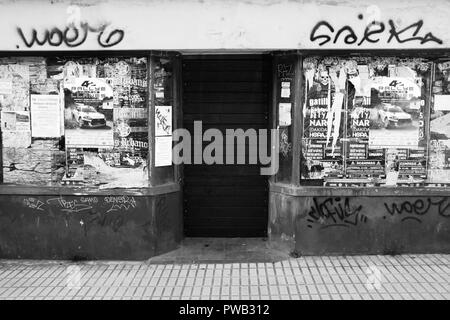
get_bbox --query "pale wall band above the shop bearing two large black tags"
[0,0,450,51]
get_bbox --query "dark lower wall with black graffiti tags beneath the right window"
[269,192,450,255]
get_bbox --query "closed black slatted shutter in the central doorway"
[182,55,271,237]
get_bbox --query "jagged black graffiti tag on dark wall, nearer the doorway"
[306,197,367,229]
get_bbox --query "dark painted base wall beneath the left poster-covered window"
[0,193,183,260]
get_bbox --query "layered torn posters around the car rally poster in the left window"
[64,58,149,188]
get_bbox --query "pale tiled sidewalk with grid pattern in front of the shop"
[0,255,450,300]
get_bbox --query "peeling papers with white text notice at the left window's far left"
[0,57,64,185]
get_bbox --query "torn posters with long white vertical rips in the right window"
[301,61,346,180]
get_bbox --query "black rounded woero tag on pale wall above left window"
[17,22,125,48]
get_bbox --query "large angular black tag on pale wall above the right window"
[310,14,443,46]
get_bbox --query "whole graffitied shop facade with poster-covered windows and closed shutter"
[0,0,450,259]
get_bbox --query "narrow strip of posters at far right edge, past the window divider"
[428,61,450,185]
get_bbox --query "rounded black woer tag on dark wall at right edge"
[384,198,450,223]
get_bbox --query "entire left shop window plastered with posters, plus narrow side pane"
[0,56,171,188]
